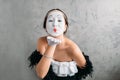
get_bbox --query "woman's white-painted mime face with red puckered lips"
[46,11,65,36]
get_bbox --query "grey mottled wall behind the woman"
[0,0,120,80]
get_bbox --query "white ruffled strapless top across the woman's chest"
[51,60,78,77]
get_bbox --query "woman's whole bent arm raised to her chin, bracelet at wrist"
[35,38,61,78]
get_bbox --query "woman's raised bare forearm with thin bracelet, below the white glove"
[36,46,56,78]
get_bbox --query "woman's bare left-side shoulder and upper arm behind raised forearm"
[37,36,47,54]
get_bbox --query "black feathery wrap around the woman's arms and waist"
[28,50,93,80]
